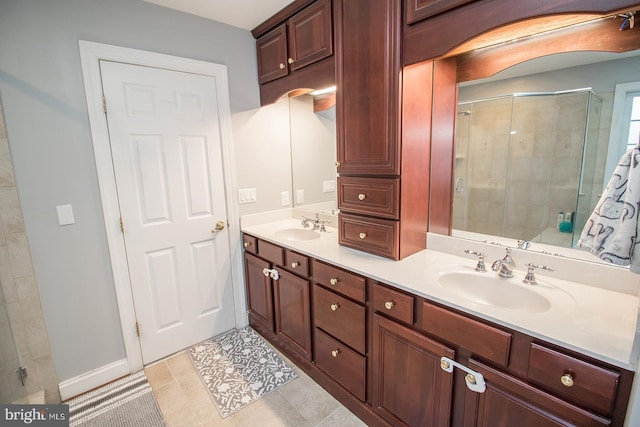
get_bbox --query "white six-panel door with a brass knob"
[100,61,235,364]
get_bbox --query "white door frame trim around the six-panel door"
[79,40,247,372]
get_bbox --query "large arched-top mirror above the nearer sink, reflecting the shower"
[452,51,640,261]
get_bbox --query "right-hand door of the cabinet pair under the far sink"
[274,269,311,360]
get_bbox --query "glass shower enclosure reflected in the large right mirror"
[453,89,607,247]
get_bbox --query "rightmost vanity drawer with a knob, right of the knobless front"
[528,344,620,414]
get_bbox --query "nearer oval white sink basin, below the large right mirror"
[438,272,551,313]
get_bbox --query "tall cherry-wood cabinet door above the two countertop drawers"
[336,0,402,175]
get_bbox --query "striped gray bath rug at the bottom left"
[64,371,166,427]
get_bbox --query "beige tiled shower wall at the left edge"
[0,100,60,403]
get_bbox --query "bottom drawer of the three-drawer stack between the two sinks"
[315,329,367,401]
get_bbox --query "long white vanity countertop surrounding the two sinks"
[241,215,639,371]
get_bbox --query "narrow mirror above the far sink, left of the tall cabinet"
[289,95,337,213]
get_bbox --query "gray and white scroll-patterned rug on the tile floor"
[189,327,298,418]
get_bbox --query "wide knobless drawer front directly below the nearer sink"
[420,302,511,366]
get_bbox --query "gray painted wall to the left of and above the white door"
[0,0,259,381]
